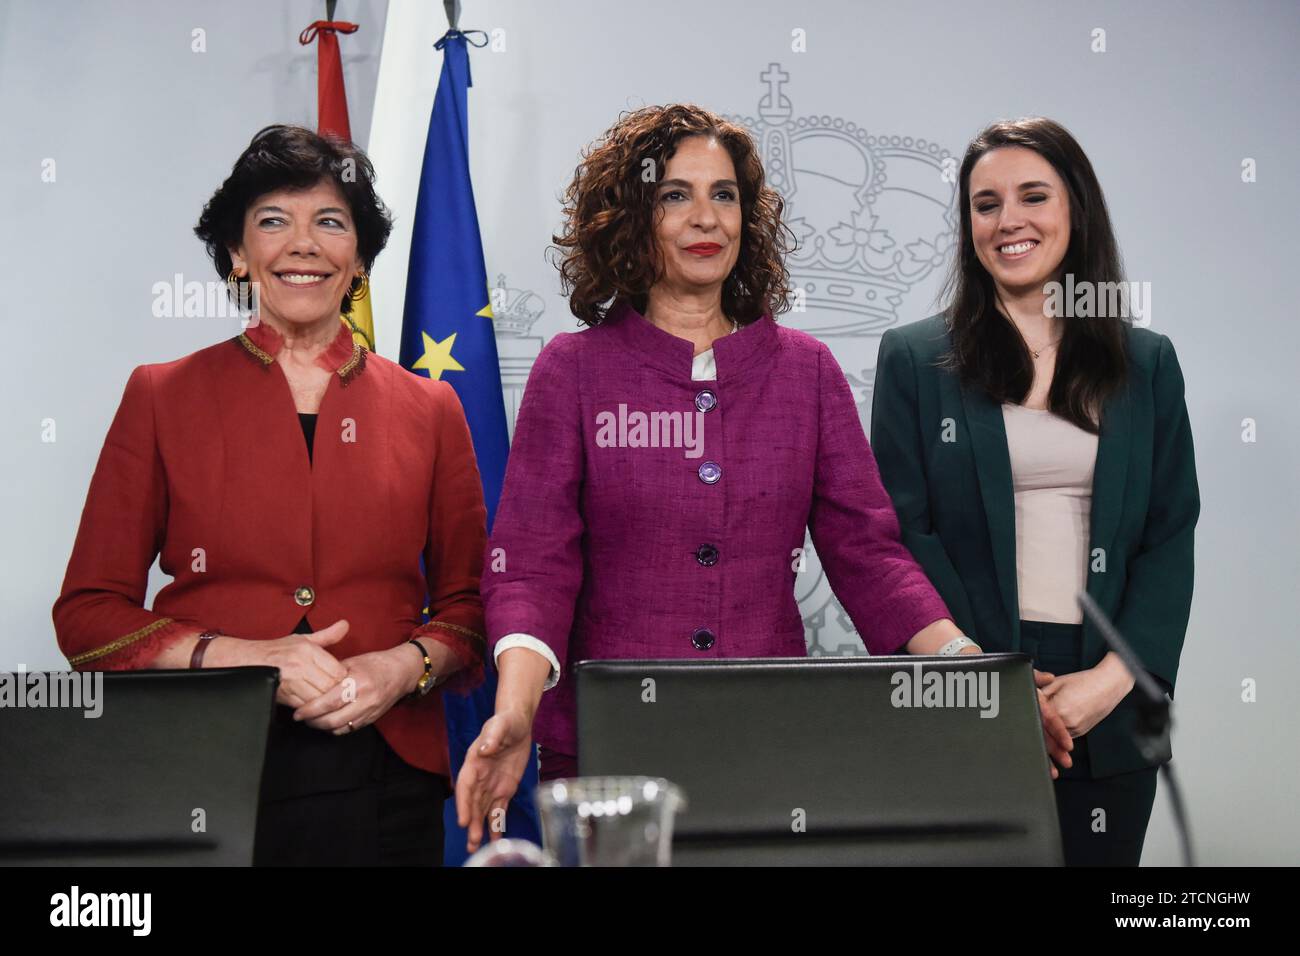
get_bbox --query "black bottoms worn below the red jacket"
[254,705,451,866]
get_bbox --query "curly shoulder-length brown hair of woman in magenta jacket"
[551,104,793,325]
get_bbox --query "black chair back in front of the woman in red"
[0,667,278,866]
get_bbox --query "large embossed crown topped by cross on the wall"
[728,62,956,336]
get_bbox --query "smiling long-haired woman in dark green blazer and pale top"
[871,118,1200,865]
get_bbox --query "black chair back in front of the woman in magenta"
[577,654,1062,865]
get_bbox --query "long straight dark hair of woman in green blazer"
[941,117,1127,434]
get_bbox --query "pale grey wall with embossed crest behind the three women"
[0,0,1300,864]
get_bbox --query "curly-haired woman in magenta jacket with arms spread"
[456,105,1069,851]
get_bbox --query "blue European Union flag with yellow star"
[400,30,541,866]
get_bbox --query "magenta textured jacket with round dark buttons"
[481,306,950,754]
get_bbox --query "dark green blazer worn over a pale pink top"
[871,316,1200,777]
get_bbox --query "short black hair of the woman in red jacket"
[194,125,393,315]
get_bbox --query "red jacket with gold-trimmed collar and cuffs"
[53,323,486,777]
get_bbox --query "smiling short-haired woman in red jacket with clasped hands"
[53,126,486,865]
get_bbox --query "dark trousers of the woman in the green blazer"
[1021,620,1158,866]
